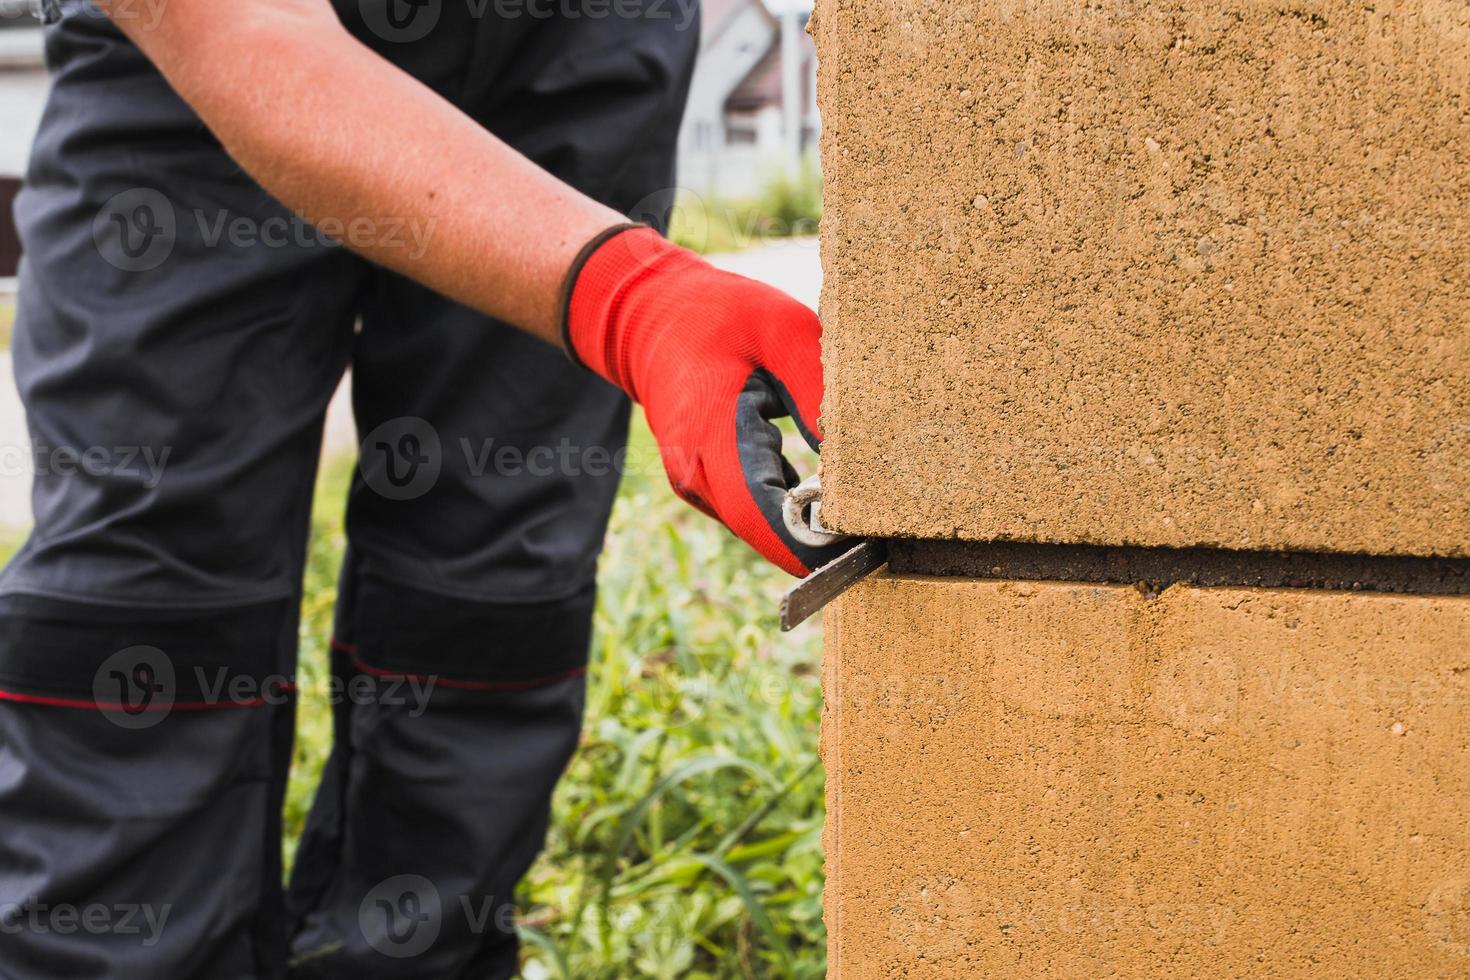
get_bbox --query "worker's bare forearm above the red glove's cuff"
[97,0,622,344]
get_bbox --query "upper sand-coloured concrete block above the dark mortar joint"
[813,0,1470,555]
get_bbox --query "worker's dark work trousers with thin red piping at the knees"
[0,0,698,980]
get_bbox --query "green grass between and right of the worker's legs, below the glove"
[287,420,826,980]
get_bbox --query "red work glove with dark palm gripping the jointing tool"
[563,225,841,576]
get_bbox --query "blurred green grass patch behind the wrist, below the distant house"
[669,163,822,253]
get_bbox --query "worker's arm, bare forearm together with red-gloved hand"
[98,0,839,574]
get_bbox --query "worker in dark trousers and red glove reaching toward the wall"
[0,0,825,980]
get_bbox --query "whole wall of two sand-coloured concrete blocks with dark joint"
[813,0,1470,979]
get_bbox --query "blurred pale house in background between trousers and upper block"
[679,0,820,197]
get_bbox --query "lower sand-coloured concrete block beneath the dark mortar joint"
[823,576,1470,980]
